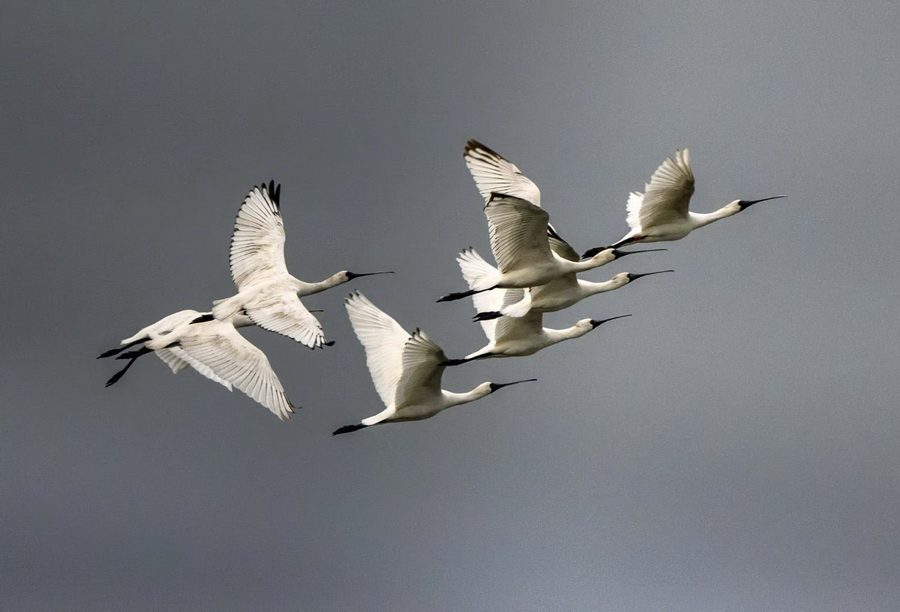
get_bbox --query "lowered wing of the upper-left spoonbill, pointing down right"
[244,291,325,349]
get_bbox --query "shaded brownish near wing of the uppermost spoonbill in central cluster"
[484,193,553,273]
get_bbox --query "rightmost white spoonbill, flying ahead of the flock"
[584,149,787,257]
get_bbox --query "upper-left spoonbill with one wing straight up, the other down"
[212,181,392,349]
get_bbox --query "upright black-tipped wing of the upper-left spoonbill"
[229,181,288,291]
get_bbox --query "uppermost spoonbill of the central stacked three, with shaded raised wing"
[438,193,656,302]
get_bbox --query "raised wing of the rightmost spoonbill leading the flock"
[627,149,694,229]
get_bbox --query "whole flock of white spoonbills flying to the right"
[98,140,785,435]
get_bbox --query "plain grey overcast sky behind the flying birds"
[0,1,900,611]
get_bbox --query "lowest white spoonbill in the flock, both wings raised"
[332,291,536,435]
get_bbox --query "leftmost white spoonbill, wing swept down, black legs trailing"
[100,310,295,420]
